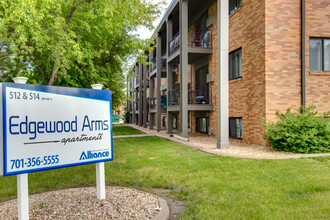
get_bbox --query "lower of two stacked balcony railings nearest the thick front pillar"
[188,86,212,105]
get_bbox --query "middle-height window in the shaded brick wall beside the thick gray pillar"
[229,48,242,80]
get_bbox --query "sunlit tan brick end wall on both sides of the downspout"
[266,0,330,121]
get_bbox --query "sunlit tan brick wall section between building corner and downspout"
[266,0,301,124]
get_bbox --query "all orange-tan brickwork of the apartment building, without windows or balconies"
[133,0,330,145]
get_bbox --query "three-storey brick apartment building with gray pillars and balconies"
[128,0,330,148]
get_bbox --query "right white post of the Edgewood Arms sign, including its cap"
[91,84,105,200]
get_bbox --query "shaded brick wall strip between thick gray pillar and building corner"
[229,0,266,144]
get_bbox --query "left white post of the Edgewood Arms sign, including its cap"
[13,77,29,220]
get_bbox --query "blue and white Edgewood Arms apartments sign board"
[0,83,113,176]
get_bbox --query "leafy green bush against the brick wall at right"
[262,105,330,153]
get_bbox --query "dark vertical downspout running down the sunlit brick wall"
[301,0,306,108]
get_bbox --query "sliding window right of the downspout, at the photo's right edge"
[309,38,330,71]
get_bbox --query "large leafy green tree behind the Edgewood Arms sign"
[0,0,159,107]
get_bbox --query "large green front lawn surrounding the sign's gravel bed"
[0,137,330,219]
